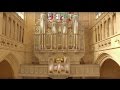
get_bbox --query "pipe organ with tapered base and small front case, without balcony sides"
[34,12,84,76]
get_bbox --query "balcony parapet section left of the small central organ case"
[19,65,48,77]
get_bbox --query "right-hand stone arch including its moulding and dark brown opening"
[95,53,120,79]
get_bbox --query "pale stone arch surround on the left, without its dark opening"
[0,52,19,78]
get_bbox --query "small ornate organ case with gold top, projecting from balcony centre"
[48,57,70,75]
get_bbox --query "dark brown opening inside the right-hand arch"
[100,59,120,79]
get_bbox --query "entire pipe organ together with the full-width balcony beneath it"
[20,12,99,79]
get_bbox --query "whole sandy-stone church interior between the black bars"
[0,12,120,79]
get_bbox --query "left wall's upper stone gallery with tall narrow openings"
[0,12,24,51]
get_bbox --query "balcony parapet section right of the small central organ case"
[70,64,100,77]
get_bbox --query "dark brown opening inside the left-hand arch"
[0,60,14,79]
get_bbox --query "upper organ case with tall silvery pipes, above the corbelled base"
[34,13,84,52]
